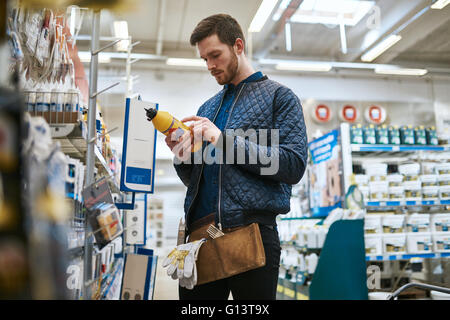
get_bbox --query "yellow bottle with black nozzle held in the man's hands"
[145,108,203,152]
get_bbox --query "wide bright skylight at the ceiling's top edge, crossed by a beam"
[273,0,375,26]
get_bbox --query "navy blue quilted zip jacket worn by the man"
[174,76,307,229]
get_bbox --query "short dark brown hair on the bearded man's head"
[190,14,245,47]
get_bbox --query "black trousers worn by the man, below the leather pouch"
[179,224,281,300]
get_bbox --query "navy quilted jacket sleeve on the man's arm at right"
[221,87,307,184]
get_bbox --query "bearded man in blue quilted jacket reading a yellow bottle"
[166,14,307,300]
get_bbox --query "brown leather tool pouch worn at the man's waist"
[189,223,266,285]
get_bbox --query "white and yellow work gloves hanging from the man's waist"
[163,239,206,289]
